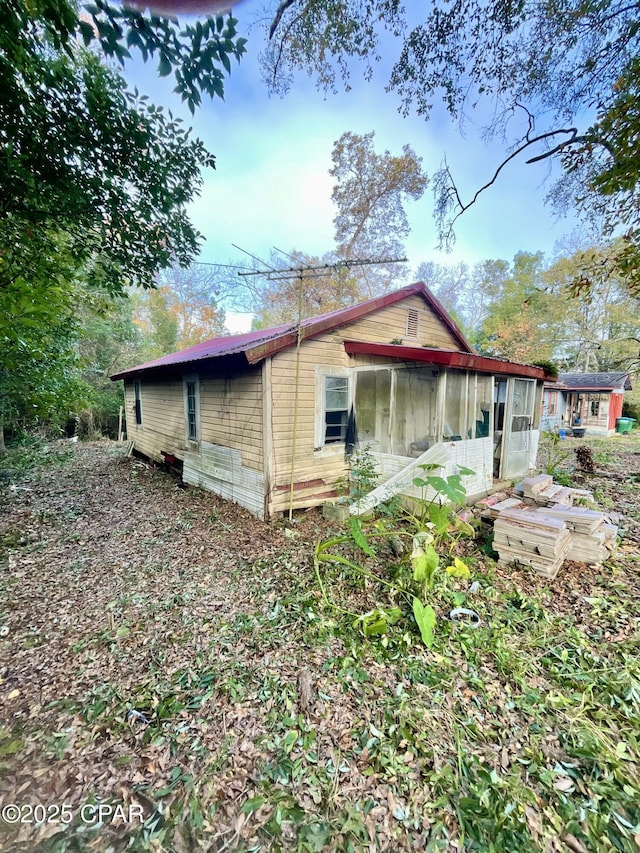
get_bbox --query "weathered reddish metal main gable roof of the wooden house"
[111,282,473,381]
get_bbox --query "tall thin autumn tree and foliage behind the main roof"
[234,131,427,328]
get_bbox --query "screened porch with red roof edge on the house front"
[345,342,543,506]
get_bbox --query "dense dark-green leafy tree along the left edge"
[0,0,244,440]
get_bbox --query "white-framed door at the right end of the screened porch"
[500,377,536,479]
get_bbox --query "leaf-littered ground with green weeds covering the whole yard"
[0,433,640,853]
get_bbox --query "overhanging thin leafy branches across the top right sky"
[263,0,640,290]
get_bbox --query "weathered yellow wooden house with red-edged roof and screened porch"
[111,283,549,518]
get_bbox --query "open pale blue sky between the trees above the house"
[126,0,572,330]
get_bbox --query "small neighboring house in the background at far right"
[540,372,631,435]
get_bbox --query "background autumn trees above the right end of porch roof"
[414,241,640,372]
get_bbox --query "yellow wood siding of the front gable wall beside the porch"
[270,296,460,512]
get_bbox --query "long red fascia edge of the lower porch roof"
[344,341,548,380]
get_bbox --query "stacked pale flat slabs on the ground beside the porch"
[484,474,618,580]
